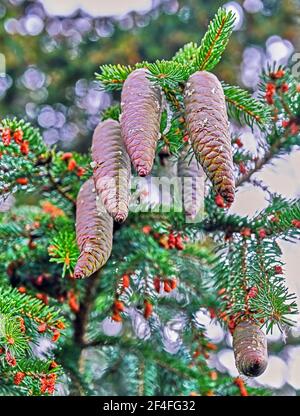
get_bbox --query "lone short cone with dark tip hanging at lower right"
[233,321,268,377]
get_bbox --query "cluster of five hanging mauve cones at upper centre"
[74,68,234,278]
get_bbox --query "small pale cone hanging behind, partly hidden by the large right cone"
[177,145,205,221]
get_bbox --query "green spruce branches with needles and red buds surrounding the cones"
[0,9,300,396]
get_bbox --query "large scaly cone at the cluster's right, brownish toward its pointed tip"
[184,71,235,203]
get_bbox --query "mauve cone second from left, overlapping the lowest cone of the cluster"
[92,120,130,222]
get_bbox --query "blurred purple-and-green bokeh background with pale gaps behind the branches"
[0,0,300,395]
